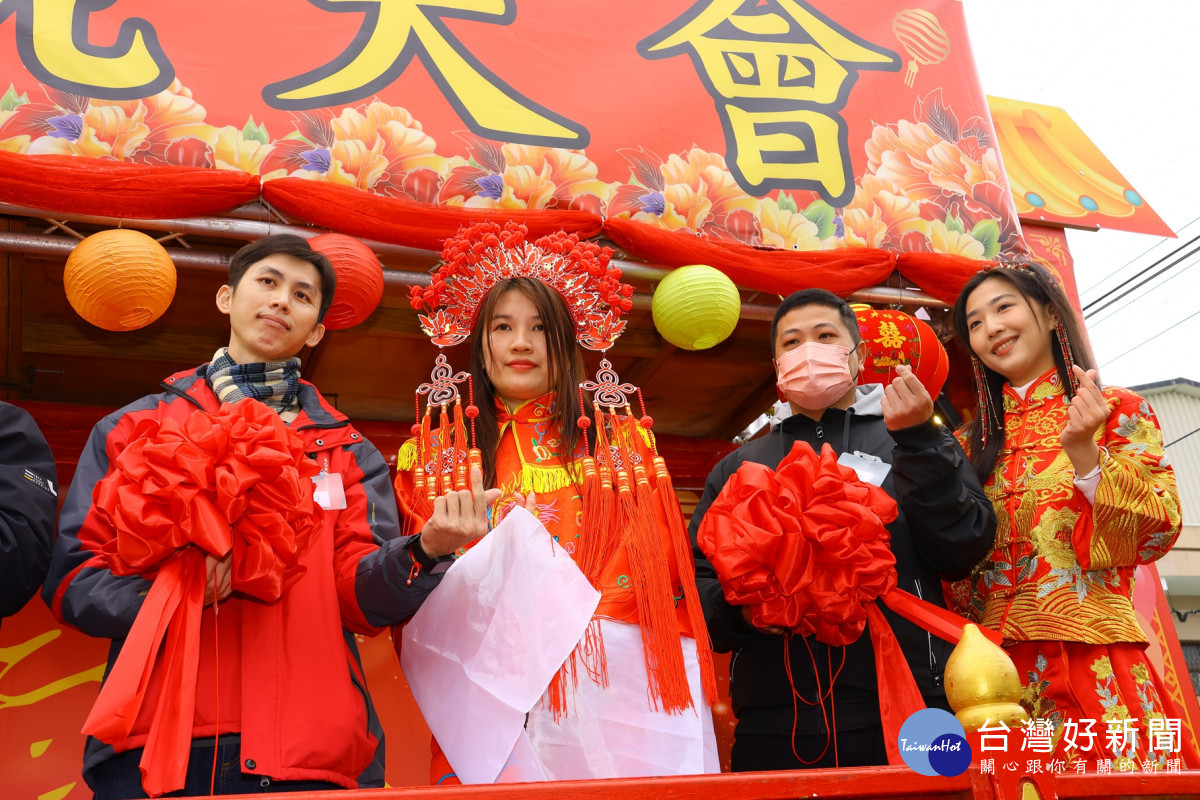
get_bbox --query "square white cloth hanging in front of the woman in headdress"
[401,507,600,783]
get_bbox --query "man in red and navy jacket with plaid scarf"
[43,235,488,799]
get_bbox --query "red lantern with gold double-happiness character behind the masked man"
[852,303,950,399]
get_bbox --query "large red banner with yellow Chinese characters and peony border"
[0,0,1024,271]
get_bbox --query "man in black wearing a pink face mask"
[691,289,996,772]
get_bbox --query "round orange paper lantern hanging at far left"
[62,229,175,331]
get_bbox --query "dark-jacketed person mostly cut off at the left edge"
[0,403,59,620]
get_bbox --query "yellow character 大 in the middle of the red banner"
[263,0,589,148]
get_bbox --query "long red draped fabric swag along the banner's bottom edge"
[0,151,989,302]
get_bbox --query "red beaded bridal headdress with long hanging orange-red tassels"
[410,222,716,714]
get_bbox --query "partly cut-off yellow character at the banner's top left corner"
[0,0,175,100]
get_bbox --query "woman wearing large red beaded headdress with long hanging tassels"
[396,223,719,783]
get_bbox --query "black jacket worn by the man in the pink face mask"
[691,386,996,735]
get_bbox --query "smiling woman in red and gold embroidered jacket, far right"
[952,265,1200,769]
